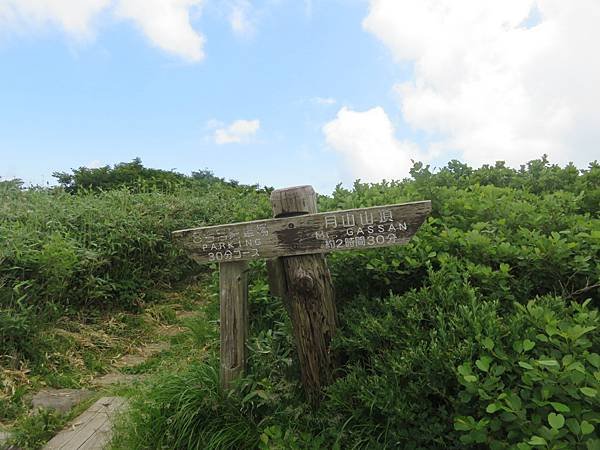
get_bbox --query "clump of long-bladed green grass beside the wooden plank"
[113,360,260,450]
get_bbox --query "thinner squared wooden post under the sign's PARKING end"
[219,261,248,389]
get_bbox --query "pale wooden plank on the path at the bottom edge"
[44,397,127,450]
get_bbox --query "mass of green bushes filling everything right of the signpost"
[104,159,600,450]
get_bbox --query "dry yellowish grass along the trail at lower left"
[0,284,211,450]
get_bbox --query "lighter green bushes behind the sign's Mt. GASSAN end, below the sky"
[321,164,600,305]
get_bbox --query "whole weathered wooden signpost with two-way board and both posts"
[173,186,431,401]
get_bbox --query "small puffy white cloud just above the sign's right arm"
[323,107,422,182]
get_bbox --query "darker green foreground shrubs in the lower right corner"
[324,274,600,449]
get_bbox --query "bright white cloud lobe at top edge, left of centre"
[115,0,205,61]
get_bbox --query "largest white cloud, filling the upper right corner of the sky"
[352,0,600,169]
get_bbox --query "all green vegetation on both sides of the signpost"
[0,158,600,450]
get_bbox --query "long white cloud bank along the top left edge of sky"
[0,0,204,61]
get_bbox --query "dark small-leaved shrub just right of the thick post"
[323,264,503,449]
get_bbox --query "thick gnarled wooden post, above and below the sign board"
[271,186,337,403]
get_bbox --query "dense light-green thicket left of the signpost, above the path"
[0,176,269,353]
